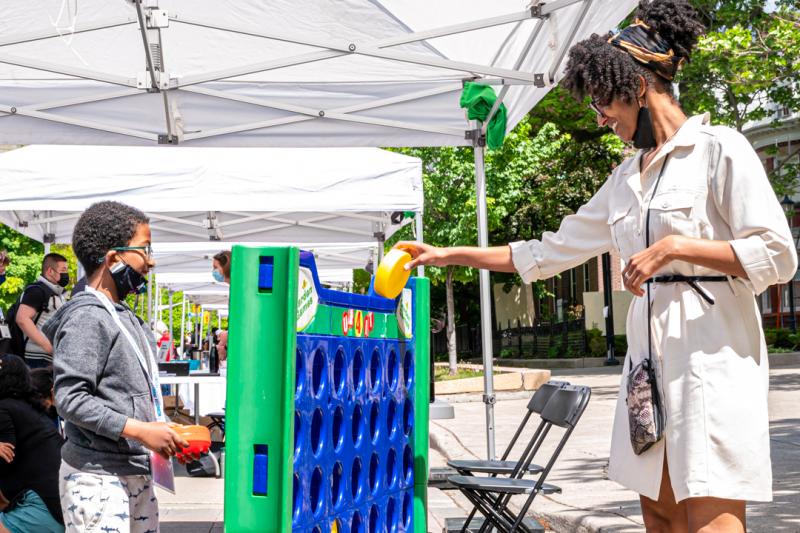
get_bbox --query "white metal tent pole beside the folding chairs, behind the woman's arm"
[474,135,495,461]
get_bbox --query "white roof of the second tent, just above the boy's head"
[0,145,423,245]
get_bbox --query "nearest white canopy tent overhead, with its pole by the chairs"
[0,0,636,458]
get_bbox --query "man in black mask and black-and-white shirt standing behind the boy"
[15,253,69,368]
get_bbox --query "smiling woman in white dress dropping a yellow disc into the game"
[398,0,797,533]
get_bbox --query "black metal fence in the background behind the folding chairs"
[431,318,587,358]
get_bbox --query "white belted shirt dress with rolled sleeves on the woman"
[511,115,797,501]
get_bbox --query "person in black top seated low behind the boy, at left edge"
[0,354,64,533]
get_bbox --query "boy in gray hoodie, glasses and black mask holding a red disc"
[44,201,188,533]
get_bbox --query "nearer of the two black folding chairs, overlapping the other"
[448,385,592,533]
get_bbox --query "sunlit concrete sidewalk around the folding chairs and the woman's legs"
[428,365,800,533]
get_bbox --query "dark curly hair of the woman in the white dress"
[562,0,705,105]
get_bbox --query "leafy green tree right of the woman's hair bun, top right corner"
[679,0,800,195]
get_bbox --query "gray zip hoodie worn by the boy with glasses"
[43,292,158,476]
